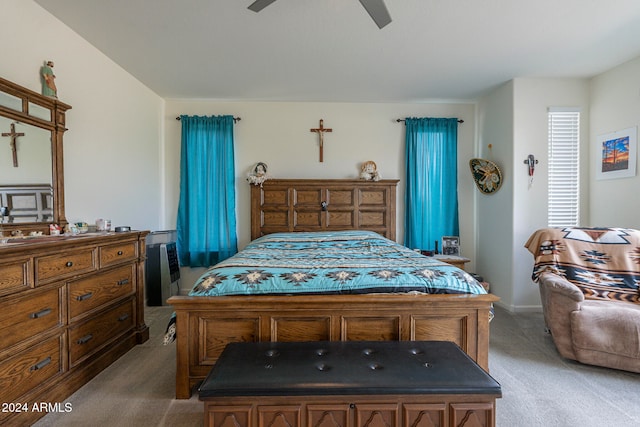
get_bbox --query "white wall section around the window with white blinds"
[510,78,589,311]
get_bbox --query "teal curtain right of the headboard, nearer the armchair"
[404,118,459,250]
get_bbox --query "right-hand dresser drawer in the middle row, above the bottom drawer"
[69,264,136,322]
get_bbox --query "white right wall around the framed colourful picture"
[589,58,640,229]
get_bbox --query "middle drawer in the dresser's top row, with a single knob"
[35,248,96,285]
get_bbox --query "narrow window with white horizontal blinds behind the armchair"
[547,108,580,227]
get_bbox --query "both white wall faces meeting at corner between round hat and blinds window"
[478,78,589,311]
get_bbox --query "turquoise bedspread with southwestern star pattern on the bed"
[189,231,486,296]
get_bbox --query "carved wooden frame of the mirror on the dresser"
[0,77,71,236]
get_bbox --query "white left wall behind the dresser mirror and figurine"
[0,0,164,229]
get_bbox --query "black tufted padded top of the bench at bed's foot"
[200,341,501,399]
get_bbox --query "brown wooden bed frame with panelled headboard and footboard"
[169,180,498,399]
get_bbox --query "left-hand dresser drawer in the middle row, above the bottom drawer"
[0,288,64,349]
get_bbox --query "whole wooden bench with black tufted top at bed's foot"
[199,341,502,427]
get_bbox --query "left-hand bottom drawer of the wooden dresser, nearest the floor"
[0,335,63,406]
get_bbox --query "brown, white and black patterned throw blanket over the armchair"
[525,227,640,304]
